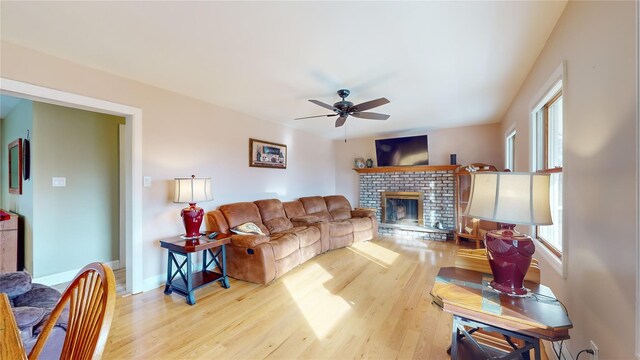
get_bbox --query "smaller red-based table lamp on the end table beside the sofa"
[173,175,213,239]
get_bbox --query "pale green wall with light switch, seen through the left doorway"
[32,102,124,277]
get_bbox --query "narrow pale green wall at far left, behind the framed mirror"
[0,100,34,271]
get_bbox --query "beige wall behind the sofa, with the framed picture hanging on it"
[0,42,335,286]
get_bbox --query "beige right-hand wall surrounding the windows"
[502,1,639,359]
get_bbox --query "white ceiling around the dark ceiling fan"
[0,1,566,138]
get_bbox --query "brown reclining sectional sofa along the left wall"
[207,195,378,284]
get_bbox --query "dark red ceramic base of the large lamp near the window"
[486,224,536,296]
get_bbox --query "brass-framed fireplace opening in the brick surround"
[380,191,424,226]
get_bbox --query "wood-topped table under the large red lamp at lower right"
[431,267,573,360]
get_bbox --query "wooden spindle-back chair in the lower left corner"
[29,263,116,360]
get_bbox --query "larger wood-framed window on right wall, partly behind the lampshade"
[533,81,563,259]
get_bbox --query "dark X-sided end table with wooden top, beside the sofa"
[160,234,231,305]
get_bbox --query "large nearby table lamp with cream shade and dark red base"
[464,171,552,296]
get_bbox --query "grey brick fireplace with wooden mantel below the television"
[356,165,456,241]
